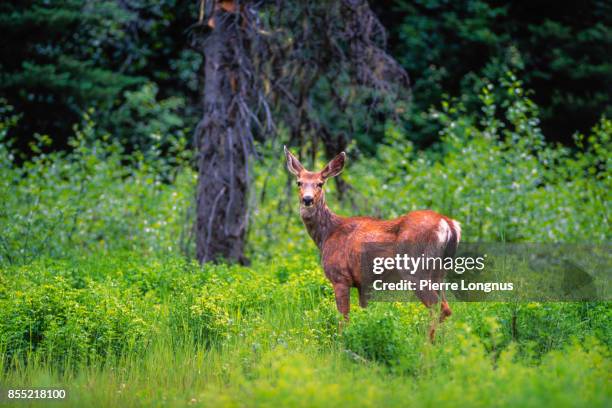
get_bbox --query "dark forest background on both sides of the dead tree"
[0,0,612,156]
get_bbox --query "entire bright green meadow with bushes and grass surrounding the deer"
[0,78,612,407]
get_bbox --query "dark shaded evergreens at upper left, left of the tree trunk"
[0,0,202,153]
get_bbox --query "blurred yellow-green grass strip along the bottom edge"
[5,339,611,407]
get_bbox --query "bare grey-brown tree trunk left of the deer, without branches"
[195,12,251,263]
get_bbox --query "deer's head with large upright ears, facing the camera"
[285,146,346,211]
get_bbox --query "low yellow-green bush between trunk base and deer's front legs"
[170,261,338,347]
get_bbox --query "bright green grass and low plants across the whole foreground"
[0,251,612,407]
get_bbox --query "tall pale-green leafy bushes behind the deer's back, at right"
[346,74,612,243]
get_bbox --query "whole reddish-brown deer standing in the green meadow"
[284,146,461,342]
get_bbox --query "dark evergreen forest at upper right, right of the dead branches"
[387,0,612,144]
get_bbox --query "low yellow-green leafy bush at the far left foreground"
[0,277,155,366]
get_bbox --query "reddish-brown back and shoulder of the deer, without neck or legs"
[321,210,460,286]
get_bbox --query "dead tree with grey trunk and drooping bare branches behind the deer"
[192,0,408,262]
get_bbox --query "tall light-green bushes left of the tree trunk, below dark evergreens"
[0,104,195,265]
